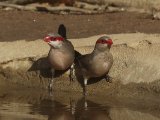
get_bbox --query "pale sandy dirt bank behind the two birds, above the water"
[0,33,160,97]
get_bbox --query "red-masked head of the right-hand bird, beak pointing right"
[95,36,113,50]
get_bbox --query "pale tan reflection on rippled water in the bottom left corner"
[0,102,46,120]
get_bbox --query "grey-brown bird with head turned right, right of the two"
[77,36,113,95]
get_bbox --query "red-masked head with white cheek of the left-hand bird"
[44,33,65,48]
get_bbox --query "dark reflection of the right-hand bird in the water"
[75,98,111,120]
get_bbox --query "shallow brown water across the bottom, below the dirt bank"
[0,89,160,120]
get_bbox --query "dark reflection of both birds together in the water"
[36,99,111,120]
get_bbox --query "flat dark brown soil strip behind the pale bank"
[0,10,160,41]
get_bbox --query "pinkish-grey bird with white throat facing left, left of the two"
[44,33,75,90]
